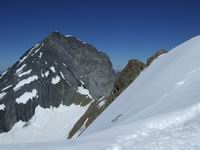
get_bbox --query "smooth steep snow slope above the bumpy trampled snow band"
[84,36,200,135]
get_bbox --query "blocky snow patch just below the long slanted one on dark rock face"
[16,89,38,104]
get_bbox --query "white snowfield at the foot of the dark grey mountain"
[0,104,89,144]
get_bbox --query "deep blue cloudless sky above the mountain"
[0,0,200,69]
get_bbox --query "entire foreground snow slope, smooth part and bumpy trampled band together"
[0,36,200,150]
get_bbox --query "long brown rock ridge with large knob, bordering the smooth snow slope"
[68,59,145,138]
